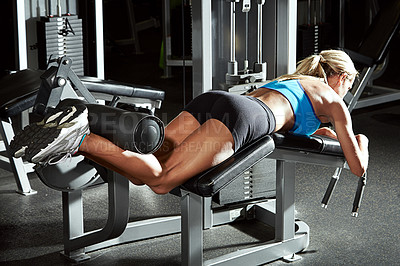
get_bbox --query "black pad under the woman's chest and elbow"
[273,133,344,156]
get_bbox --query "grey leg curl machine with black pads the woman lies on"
[1,58,365,265]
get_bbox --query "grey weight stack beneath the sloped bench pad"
[213,159,276,205]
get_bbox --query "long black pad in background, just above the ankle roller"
[79,77,165,101]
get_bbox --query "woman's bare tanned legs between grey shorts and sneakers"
[80,114,234,194]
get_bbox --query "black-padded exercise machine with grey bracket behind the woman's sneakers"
[0,57,164,195]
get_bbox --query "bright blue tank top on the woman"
[262,80,321,136]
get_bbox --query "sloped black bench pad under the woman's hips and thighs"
[182,135,275,197]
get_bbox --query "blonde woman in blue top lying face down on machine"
[12,50,368,194]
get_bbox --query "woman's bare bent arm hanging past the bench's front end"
[329,102,369,176]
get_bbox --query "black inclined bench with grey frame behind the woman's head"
[344,1,400,112]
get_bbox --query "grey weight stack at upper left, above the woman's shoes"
[37,15,84,75]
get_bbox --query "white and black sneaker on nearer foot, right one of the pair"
[25,105,90,163]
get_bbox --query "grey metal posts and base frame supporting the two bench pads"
[181,160,309,265]
